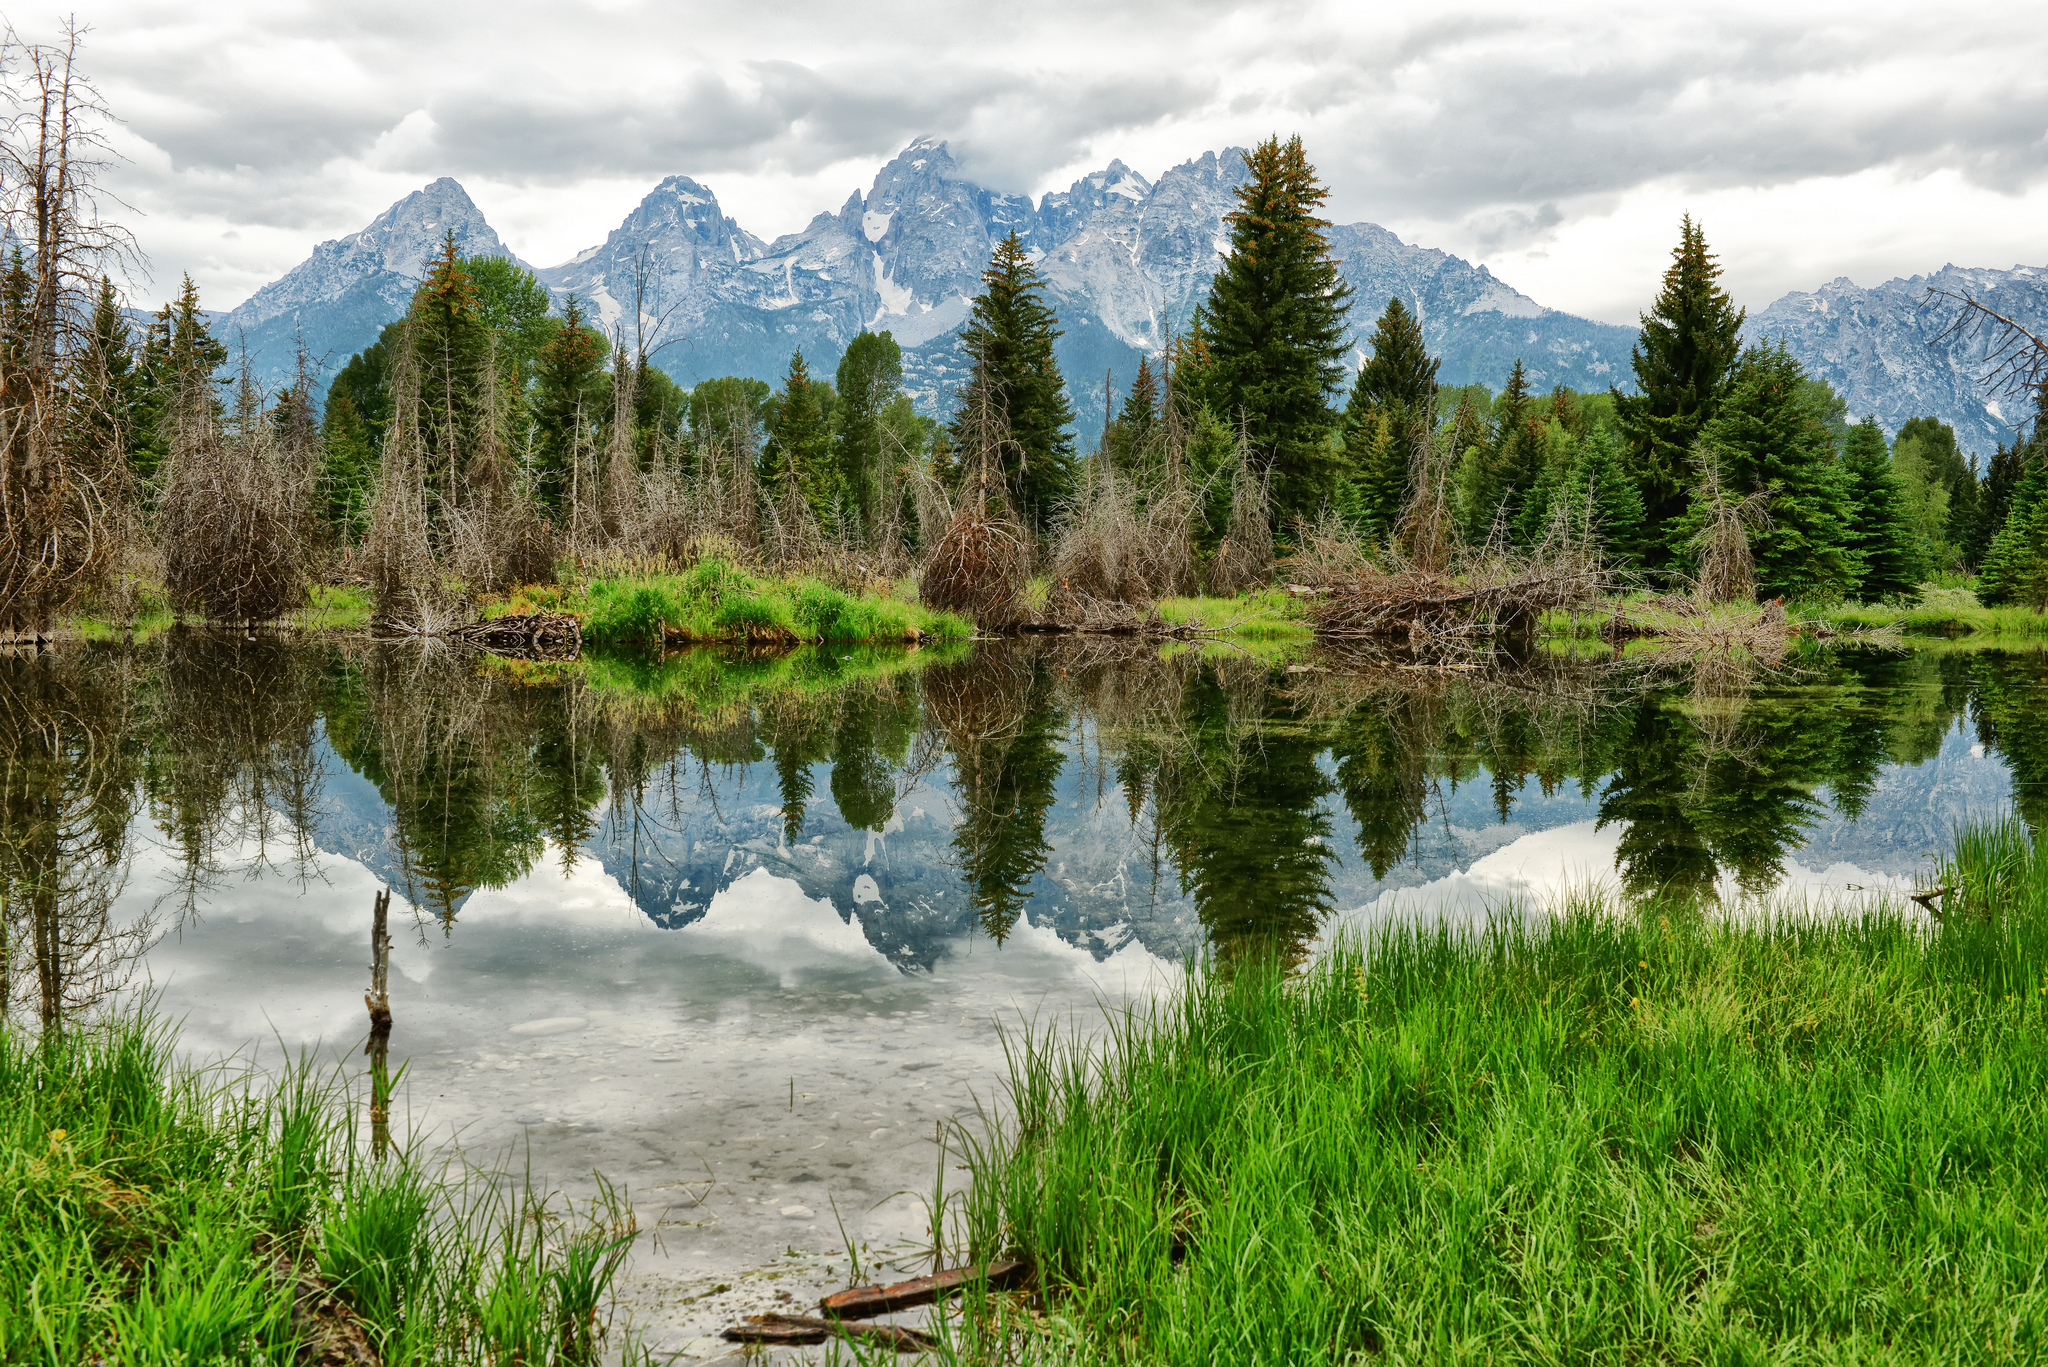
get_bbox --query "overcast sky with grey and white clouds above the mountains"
[32,0,2048,322]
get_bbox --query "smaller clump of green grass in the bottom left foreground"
[0,1017,631,1367]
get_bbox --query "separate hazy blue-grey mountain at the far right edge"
[1749,266,2048,457]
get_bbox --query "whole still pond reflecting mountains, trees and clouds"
[0,633,2048,1353]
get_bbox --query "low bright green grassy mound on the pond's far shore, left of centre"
[495,560,973,646]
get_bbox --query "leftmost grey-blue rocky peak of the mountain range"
[213,176,524,385]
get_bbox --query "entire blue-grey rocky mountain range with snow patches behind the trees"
[221,139,2048,453]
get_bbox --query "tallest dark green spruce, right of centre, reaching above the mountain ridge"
[1204,137,1352,525]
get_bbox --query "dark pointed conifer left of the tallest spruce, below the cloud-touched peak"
[952,232,1073,531]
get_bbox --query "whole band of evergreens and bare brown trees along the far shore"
[0,26,2048,631]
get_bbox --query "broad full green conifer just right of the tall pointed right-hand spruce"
[1695,346,1855,598]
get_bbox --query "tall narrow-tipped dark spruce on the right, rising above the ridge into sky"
[1612,215,1747,568]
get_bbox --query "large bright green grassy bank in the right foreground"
[971,824,2048,1365]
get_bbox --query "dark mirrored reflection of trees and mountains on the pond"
[0,631,2048,1021]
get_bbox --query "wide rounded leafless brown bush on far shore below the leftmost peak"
[158,361,317,621]
